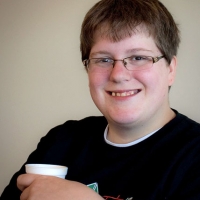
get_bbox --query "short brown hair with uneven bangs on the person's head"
[80,0,180,64]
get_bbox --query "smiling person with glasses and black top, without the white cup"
[1,0,200,200]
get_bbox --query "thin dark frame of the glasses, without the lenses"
[83,55,165,71]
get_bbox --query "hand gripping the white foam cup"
[17,174,103,200]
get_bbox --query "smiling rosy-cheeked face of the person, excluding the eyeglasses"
[88,29,176,130]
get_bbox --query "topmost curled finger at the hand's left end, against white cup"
[17,174,38,191]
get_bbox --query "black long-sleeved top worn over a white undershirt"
[1,112,200,200]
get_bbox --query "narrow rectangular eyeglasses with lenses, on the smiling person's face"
[83,55,165,73]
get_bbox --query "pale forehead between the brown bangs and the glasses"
[90,28,159,57]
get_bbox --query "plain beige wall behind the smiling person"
[0,0,200,193]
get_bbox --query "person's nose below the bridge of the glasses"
[110,60,131,82]
